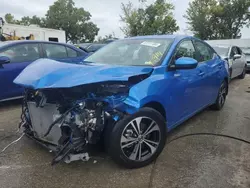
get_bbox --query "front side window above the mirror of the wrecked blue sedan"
[175,40,195,59]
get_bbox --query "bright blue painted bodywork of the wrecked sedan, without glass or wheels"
[15,35,228,130]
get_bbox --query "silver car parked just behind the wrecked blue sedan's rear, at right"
[213,46,247,79]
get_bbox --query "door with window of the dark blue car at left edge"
[0,43,41,100]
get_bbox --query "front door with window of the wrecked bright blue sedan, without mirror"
[166,40,207,126]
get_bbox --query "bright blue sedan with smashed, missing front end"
[14,35,228,168]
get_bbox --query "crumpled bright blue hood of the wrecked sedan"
[14,59,153,89]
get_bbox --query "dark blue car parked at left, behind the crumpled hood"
[0,41,88,101]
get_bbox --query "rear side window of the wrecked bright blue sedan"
[195,41,214,62]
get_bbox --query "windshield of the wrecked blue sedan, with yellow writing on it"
[85,39,173,66]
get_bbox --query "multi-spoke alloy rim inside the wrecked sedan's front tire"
[120,117,161,161]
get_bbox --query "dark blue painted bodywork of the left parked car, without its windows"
[0,40,88,101]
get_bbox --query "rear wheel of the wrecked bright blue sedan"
[211,81,228,110]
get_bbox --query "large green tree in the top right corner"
[185,0,250,40]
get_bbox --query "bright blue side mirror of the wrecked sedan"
[175,57,198,69]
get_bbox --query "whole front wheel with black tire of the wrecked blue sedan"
[106,107,166,168]
